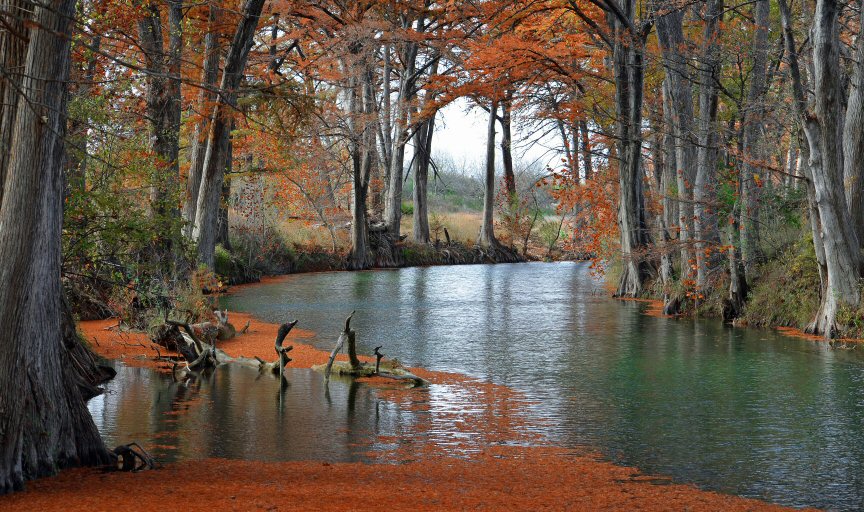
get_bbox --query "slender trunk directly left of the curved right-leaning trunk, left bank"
[183,0,221,237]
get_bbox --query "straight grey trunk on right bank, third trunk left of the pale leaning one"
[693,0,723,292]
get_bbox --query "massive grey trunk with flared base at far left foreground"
[0,0,111,494]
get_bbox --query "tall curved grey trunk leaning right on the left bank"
[192,0,264,269]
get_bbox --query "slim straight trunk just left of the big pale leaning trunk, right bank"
[739,0,771,282]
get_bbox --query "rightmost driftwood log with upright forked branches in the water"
[312,311,428,386]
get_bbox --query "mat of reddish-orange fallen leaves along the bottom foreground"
[0,448,804,512]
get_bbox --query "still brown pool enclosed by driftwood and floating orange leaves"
[89,365,415,462]
